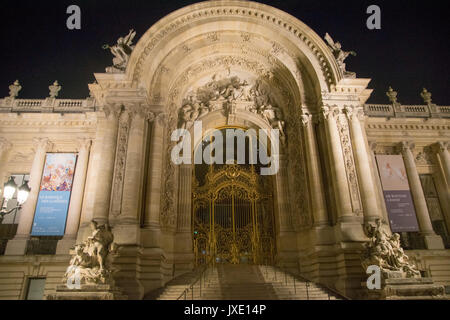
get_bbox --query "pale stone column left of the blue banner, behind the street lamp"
[5,138,52,255]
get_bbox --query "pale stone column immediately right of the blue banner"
[56,139,92,254]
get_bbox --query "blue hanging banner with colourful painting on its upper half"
[31,153,77,236]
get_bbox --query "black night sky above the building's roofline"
[0,0,450,105]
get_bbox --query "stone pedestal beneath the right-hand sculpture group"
[363,272,450,300]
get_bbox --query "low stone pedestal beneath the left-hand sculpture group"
[45,284,128,300]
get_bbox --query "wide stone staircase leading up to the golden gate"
[151,264,341,300]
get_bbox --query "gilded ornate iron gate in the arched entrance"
[192,165,275,265]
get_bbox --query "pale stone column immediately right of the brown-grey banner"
[399,141,444,249]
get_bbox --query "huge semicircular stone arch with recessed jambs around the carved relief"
[118,1,342,276]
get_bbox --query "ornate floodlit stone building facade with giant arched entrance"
[0,1,450,299]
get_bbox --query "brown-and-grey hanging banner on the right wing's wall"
[376,155,419,232]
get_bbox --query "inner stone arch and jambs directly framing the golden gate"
[172,91,296,272]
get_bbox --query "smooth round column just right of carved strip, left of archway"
[111,104,155,244]
